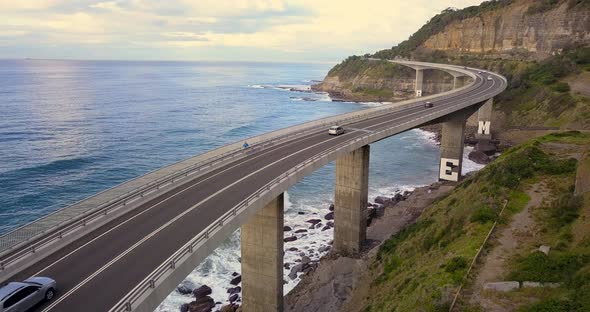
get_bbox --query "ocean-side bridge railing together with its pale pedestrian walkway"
[0,61,484,272]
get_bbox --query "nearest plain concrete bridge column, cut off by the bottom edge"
[241,194,284,312]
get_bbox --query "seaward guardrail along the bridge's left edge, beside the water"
[0,64,486,272]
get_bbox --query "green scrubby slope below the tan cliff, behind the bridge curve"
[328,47,590,129]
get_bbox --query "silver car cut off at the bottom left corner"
[0,276,56,312]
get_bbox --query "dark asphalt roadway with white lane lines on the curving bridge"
[5,64,505,312]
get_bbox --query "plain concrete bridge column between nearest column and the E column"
[334,145,370,255]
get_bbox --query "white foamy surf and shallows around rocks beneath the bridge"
[156,130,484,312]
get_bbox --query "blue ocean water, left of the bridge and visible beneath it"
[0,60,481,312]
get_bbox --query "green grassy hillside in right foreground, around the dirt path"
[362,132,590,311]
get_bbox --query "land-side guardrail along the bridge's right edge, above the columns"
[110,69,505,312]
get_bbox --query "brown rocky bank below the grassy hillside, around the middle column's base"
[285,182,455,312]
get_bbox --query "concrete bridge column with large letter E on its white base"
[439,112,468,181]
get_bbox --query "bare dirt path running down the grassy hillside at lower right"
[470,182,549,312]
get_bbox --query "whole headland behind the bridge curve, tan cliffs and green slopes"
[314,0,590,131]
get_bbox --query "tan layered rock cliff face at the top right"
[421,0,590,59]
